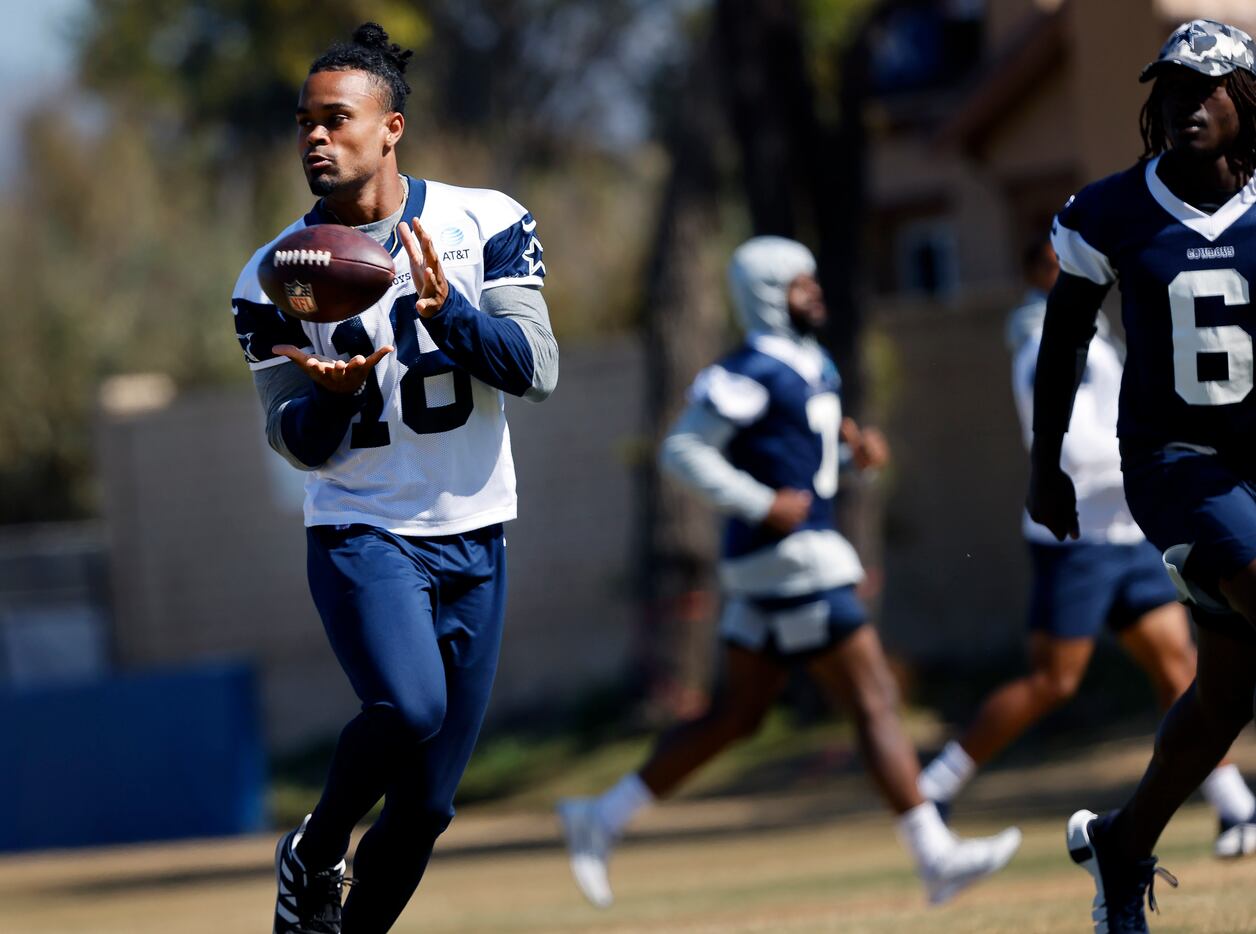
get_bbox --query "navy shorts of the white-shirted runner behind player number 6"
[1029,541,1178,639]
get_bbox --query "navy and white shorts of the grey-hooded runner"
[720,585,868,658]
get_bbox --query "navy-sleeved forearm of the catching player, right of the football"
[420,285,535,395]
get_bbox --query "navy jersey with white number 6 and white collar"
[1051,158,1256,449]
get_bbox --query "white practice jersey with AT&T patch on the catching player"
[232,178,545,536]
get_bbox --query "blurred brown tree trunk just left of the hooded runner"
[637,32,727,718]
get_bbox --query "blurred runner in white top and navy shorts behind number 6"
[921,241,1256,856]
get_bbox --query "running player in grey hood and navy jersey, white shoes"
[559,237,1020,906]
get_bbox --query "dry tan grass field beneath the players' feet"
[7,738,1256,934]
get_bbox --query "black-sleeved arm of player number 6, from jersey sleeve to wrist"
[1034,275,1107,454]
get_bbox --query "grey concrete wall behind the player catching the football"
[99,343,642,748]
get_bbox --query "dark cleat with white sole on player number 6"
[1068,811,1178,934]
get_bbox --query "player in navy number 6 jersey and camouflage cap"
[1029,20,1256,931]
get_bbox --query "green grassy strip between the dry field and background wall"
[270,643,1158,826]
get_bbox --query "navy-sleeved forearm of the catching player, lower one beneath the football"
[254,364,365,471]
